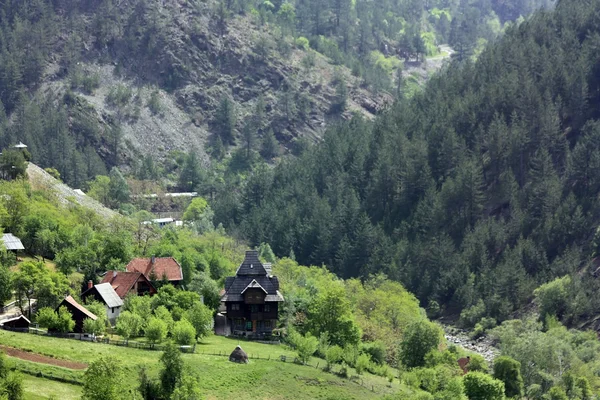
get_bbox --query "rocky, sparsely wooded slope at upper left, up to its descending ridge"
[0,0,391,186]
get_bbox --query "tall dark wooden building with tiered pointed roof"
[221,250,283,337]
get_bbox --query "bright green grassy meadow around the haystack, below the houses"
[0,331,400,400]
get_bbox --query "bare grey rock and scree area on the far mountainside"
[41,0,392,164]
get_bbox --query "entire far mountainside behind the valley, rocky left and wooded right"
[0,0,552,189]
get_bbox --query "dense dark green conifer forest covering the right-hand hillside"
[219,0,600,330]
